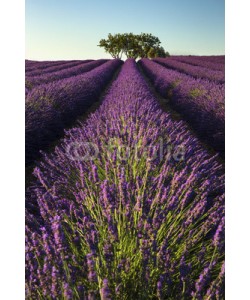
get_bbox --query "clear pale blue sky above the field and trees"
[25,0,225,60]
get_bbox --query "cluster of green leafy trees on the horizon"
[98,33,169,59]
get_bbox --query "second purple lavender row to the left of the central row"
[25,59,108,92]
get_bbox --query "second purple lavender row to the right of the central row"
[153,57,225,83]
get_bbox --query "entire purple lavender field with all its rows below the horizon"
[25,56,225,300]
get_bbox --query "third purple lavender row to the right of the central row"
[171,56,225,72]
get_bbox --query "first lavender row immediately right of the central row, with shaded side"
[139,59,225,156]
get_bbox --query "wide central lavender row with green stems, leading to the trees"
[26,60,224,300]
